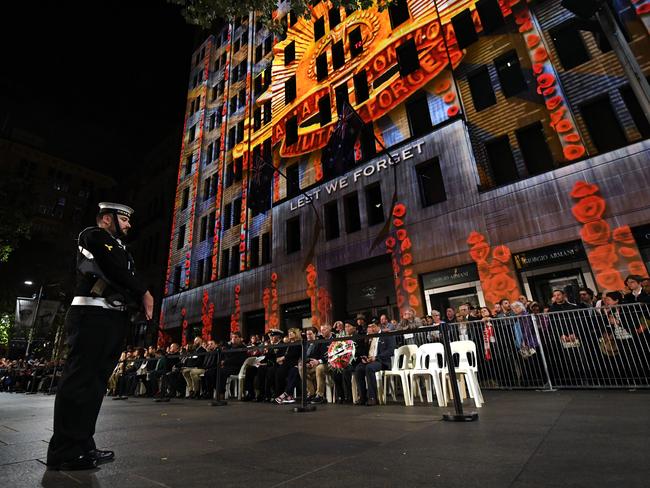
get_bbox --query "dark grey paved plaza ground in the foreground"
[0,391,650,488]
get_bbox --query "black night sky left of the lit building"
[0,0,198,180]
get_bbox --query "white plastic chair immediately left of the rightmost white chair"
[407,342,447,407]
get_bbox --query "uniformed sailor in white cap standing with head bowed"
[47,202,153,470]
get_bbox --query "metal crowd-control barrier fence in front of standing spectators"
[442,303,650,389]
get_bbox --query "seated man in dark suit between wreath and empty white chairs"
[354,322,395,407]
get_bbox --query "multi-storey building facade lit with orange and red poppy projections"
[161,0,650,344]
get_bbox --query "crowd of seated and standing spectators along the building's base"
[5,275,650,406]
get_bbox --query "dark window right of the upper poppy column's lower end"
[580,95,627,153]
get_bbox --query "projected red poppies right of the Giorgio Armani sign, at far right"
[570,181,647,291]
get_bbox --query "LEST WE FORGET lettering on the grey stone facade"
[290,140,425,212]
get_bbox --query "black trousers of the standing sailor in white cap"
[47,306,127,464]
